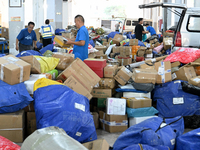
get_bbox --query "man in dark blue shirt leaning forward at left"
[16,22,37,52]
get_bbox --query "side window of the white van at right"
[187,15,200,32]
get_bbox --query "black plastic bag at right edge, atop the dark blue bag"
[181,82,200,96]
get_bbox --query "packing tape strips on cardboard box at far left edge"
[1,57,24,83]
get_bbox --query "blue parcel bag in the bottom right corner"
[176,128,200,150]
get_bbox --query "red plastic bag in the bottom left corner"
[0,136,20,150]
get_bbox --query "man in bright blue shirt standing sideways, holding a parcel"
[65,15,89,60]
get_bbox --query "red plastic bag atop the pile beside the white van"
[164,48,200,64]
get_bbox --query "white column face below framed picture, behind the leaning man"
[8,0,24,55]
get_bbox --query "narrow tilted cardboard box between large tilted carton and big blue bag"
[64,76,92,100]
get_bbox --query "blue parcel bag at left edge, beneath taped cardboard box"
[0,80,33,113]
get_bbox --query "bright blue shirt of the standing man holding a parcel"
[73,26,89,60]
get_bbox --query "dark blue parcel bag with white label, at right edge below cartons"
[153,80,200,117]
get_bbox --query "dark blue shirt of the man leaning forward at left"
[17,28,37,45]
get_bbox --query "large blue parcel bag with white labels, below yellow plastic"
[34,83,97,143]
